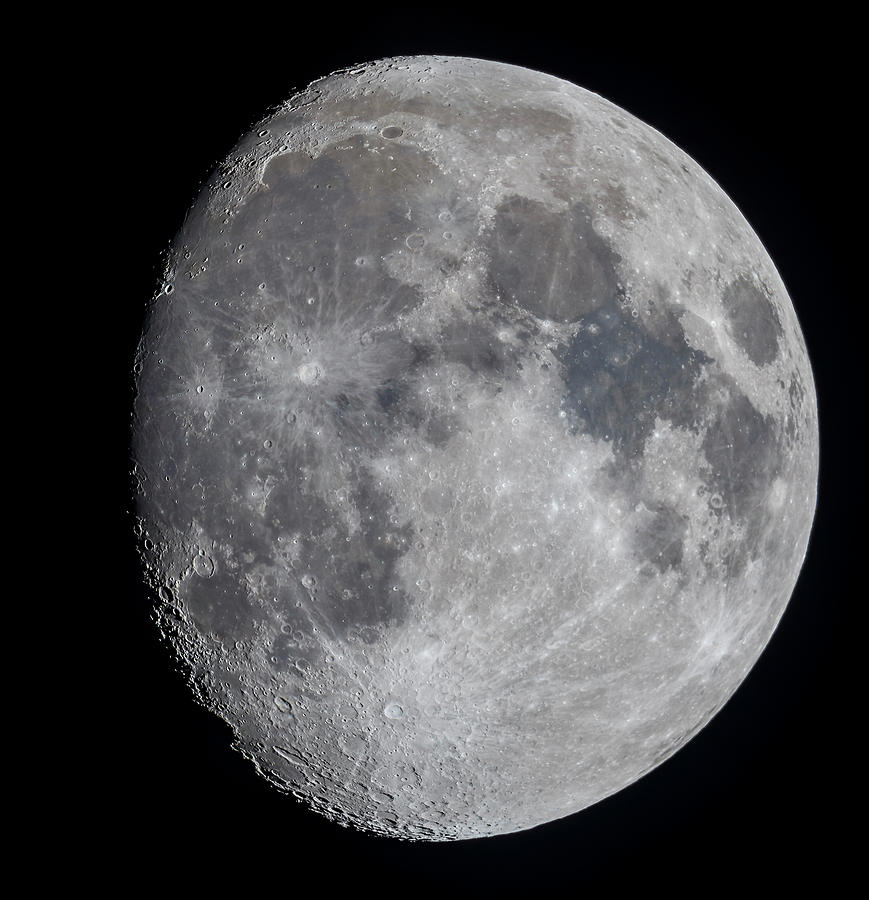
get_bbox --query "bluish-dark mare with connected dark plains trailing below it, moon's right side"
[560,299,788,575]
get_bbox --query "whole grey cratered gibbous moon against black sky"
[132,56,818,841]
